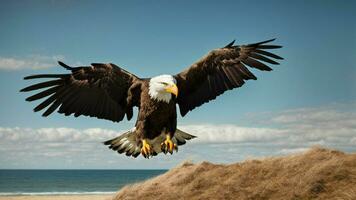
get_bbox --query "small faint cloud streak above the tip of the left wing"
[0,55,64,70]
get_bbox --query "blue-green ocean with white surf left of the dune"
[0,170,167,196]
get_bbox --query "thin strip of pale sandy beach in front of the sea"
[0,194,114,200]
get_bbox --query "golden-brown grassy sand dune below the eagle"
[115,148,356,200]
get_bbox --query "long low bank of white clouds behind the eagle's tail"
[0,104,356,168]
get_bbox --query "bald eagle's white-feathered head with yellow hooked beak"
[148,75,178,103]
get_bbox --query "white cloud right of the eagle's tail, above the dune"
[180,103,356,146]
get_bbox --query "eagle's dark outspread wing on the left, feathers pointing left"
[21,62,139,122]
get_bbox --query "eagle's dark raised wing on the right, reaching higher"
[175,39,282,116]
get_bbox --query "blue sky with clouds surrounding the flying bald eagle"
[0,1,356,168]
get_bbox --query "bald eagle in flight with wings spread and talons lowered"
[21,39,283,158]
